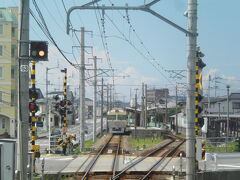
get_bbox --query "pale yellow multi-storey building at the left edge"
[0,7,18,137]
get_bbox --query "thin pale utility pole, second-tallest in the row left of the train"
[93,56,97,142]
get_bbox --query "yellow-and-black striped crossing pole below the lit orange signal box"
[29,60,40,172]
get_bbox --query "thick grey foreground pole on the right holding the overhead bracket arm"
[186,0,197,180]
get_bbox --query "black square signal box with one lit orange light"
[30,41,48,61]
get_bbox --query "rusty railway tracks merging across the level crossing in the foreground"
[73,134,185,180]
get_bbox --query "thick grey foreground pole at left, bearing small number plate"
[18,0,29,180]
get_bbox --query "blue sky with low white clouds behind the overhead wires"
[0,0,240,99]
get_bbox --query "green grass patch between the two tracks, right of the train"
[129,137,164,149]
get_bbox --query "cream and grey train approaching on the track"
[107,108,128,134]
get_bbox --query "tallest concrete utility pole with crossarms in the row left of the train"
[78,27,85,151]
